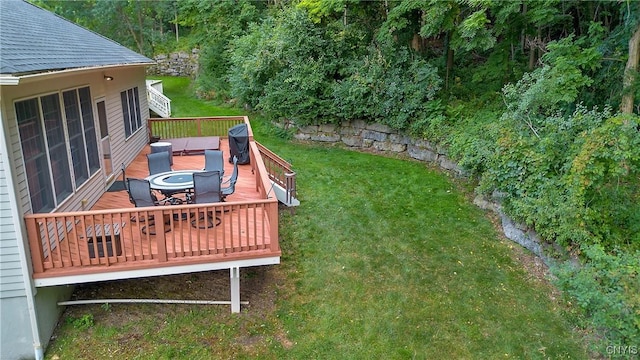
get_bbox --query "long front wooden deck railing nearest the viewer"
[24,200,279,277]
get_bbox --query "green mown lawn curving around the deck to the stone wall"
[47,79,588,359]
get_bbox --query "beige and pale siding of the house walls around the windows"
[0,66,149,359]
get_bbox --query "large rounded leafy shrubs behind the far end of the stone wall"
[229,8,441,129]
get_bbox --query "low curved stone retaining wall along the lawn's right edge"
[294,121,557,266]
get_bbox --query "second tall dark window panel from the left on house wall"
[40,94,73,203]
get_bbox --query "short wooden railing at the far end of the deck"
[148,116,253,139]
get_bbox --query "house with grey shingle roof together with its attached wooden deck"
[0,0,284,359]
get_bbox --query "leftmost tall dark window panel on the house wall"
[15,99,55,213]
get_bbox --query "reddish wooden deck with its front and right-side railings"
[25,134,280,286]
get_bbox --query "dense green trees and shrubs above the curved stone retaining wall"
[42,0,640,354]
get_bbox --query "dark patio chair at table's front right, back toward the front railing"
[191,171,222,229]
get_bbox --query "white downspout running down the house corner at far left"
[0,100,44,360]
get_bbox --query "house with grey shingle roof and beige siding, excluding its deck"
[0,1,152,359]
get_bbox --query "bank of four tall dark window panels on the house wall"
[15,87,100,213]
